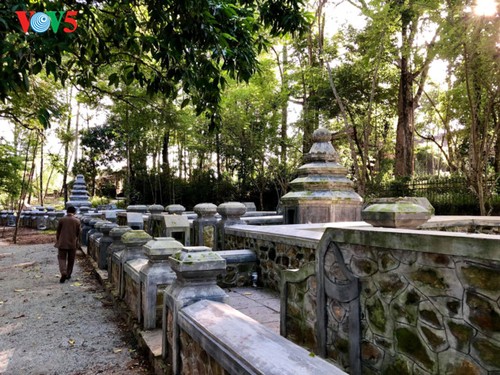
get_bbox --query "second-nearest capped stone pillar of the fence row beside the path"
[140,237,182,330]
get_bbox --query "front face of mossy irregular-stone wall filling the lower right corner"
[316,228,500,374]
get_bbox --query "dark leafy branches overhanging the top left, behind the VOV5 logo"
[0,0,308,117]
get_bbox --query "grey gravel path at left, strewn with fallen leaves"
[0,231,151,375]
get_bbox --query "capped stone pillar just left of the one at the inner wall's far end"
[193,203,217,249]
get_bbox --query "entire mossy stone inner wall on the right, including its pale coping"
[226,218,500,374]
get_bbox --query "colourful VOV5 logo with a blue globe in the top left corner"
[16,10,78,33]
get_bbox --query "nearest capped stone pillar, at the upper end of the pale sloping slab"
[162,246,227,375]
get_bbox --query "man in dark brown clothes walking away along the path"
[54,206,80,283]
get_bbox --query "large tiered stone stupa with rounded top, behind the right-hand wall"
[281,128,363,224]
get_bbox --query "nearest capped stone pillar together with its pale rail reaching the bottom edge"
[162,247,345,375]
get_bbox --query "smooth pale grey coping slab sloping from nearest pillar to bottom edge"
[179,300,346,375]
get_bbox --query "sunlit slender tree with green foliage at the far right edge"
[422,2,500,215]
